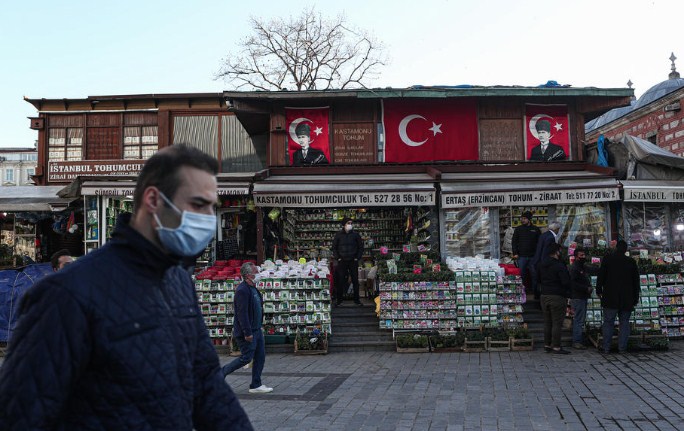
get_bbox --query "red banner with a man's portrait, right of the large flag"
[525,105,570,162]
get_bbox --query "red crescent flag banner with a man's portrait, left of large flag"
[285,107,330,166]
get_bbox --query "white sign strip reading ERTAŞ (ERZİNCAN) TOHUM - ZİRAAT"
[442,188,620,208]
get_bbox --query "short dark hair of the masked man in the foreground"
[133,144,218,211]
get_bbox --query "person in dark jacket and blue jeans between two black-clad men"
[570,248,594,350]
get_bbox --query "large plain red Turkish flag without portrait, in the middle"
[382,98,479,162]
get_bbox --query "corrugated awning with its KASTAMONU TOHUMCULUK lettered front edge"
[254,174,435,208]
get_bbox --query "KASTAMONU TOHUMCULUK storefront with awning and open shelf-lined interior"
[254,173,438,261]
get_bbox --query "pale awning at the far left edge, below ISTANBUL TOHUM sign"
[0,186,74,212]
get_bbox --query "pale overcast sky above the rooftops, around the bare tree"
[0,0,684,147]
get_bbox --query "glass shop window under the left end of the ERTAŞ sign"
[444,208,492,258]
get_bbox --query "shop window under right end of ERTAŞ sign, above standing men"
[556,203,609,248]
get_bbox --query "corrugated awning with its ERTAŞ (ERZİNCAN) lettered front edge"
[440,172,620,208]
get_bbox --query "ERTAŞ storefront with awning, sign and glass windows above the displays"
[440,166,619,259]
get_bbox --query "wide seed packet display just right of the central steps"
[379,271,525,331]
